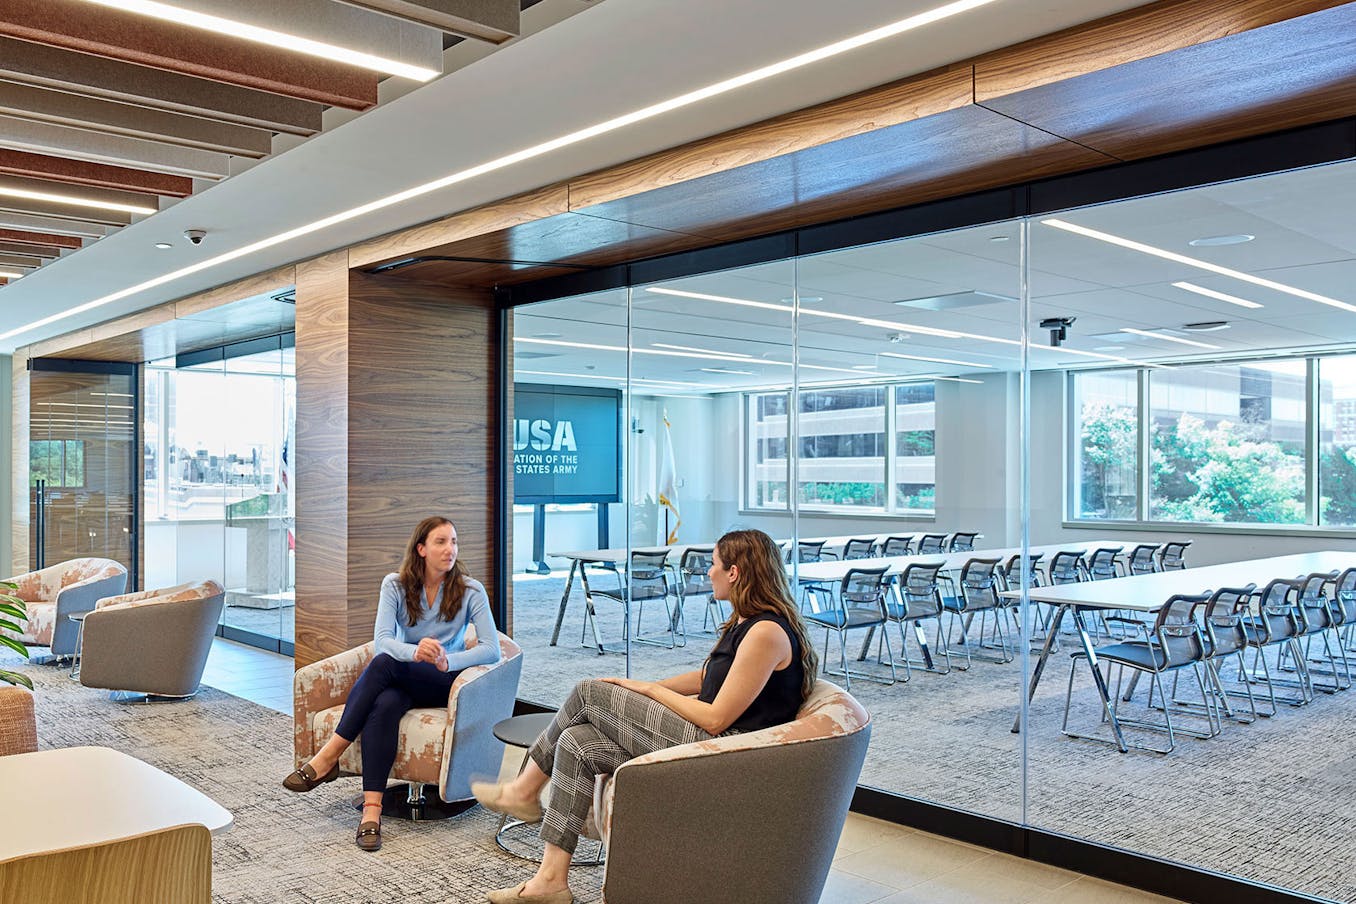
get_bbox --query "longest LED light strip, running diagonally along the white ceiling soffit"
[0,0,997,340]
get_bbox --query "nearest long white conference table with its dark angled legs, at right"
[1002,550,1356,754]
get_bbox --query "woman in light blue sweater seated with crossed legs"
[282,516,499,851]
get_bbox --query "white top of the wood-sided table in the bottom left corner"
[0,747,233,861]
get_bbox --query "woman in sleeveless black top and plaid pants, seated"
[471,530,819,904]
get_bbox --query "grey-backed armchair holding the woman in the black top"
[594,680,871,904]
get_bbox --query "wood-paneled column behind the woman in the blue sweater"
[296,252,502,667]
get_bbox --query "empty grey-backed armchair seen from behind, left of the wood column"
[80,580,225,701]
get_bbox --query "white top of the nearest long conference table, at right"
[1003,550,1356,613]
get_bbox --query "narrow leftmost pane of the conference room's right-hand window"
[1073,370,1139,520]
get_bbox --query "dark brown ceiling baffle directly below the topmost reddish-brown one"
[0,37,324,137]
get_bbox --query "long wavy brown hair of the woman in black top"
[716,530,819,701]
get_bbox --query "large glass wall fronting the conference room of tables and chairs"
[510,163,1356,900]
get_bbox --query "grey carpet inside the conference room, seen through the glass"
[514,573,1356,901]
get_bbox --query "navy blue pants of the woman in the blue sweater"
[335,653,461,792]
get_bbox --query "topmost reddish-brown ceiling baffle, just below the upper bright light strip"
[0,0,378,110]
